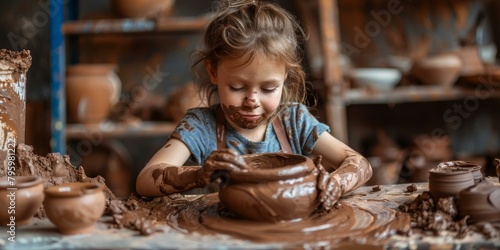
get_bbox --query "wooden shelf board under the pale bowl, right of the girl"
[343,86,492,105]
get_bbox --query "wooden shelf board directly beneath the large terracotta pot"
[66,121,176,139]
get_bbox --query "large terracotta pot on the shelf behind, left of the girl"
[66,64,121,124]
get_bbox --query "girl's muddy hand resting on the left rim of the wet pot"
[197,149,247,185]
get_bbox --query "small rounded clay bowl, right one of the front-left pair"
[43,182,105,235]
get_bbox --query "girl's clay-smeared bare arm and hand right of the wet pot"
[313,132,372,206]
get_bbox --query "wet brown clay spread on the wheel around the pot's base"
[107,190,410,247]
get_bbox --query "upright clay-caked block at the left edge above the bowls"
[0,49,32,170]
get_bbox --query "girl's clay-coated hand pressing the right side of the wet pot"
[314,156,342,211]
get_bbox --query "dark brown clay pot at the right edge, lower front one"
[458,181,500,223]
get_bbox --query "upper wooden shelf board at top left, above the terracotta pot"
[62,15,209,35]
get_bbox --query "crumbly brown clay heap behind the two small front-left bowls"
[0,144,116,218]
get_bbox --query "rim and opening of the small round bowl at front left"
[45,182,103,197]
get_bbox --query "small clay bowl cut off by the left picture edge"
[0,176,44,227]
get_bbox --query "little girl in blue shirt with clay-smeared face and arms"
[136,0,372,210]
